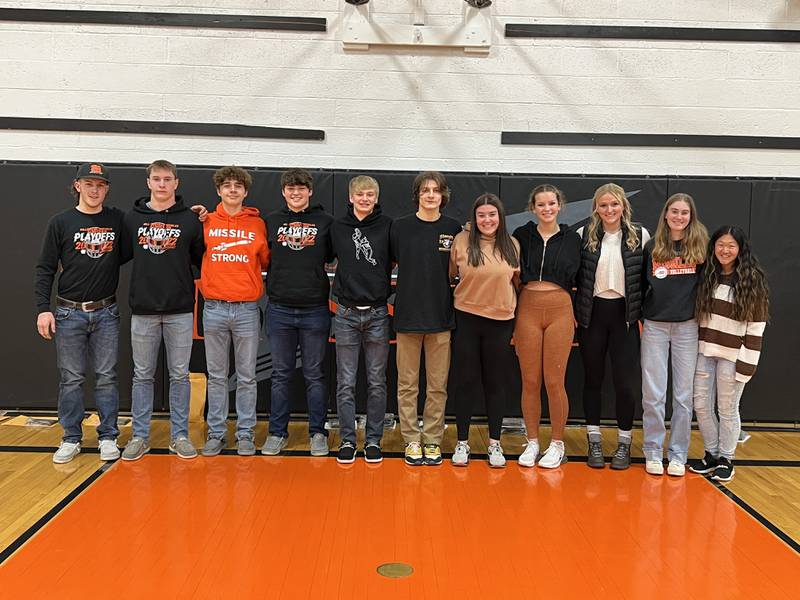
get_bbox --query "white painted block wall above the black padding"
[0,0,800,177]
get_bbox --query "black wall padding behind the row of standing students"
[6,163,800,422]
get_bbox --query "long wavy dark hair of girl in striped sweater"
[697,225,769,321]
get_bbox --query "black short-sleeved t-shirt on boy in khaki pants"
[391,215,461,333]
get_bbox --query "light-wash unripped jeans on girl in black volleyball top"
[642,319,698,464]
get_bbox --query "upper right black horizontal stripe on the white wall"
[505,23,800,43]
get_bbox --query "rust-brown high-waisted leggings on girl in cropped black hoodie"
[514,289,575,440]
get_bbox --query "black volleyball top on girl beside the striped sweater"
[642,240,702,323]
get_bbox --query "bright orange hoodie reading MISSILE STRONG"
[200,202,269,302]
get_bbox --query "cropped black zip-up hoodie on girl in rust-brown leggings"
[512,221,581,294]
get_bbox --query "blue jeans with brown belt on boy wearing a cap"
[55,304,119,443]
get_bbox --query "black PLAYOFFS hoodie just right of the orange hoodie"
[267,205,333,308]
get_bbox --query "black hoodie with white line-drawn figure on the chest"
[331,204,392,308]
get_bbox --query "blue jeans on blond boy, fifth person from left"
[333,305,389,446]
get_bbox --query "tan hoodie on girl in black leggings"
[450,231,519,321]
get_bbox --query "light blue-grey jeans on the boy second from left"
[131,313,194,440]
